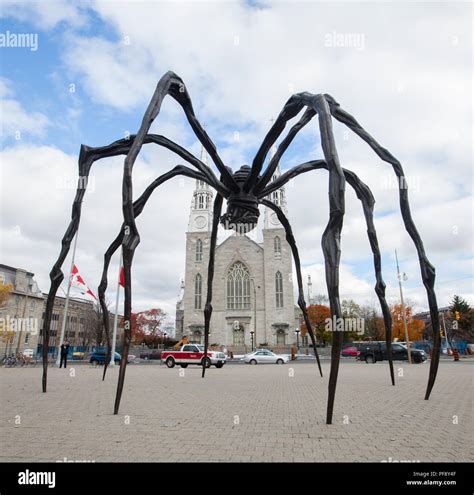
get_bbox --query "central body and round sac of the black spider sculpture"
[220,165,260,234]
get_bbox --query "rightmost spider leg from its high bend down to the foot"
[325,95,441,400]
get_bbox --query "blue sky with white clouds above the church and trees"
[0,0,474,324]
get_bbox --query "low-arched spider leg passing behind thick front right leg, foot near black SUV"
[261,160,395,385]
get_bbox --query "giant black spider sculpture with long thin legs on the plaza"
[42,72,440,424]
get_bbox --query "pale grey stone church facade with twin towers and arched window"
[176,153,297,350]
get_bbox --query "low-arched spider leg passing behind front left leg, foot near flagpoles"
[98,165,208,380]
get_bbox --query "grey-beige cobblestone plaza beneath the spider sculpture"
[0,360,474,462]
